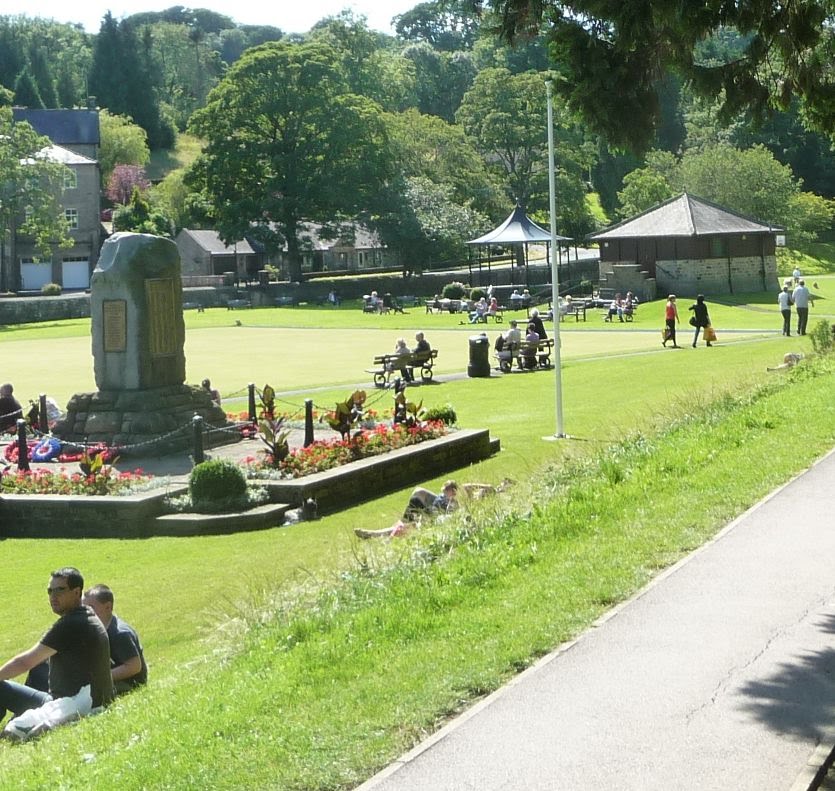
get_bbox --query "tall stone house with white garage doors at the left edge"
[7,107,102,291]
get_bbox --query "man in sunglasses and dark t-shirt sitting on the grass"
[0,566,113,732]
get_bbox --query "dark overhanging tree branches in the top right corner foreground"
[476,0,835,151]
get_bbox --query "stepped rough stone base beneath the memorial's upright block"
[52,385,235,456]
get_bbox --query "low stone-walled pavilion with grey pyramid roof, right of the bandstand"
[586,192,783,300]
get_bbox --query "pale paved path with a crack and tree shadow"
[361,451,835,791]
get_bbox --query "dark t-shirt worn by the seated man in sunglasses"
[41,605,113,706]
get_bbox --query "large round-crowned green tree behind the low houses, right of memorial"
[190,41,391,279]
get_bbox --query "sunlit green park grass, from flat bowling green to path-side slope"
[0,292,835,789]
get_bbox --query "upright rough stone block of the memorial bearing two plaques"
[90,233,186,390]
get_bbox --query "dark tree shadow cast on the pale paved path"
[740,614,835,740]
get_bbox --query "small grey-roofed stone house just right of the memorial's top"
[174,228,262,286]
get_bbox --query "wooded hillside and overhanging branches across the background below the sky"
[0,0,835,275]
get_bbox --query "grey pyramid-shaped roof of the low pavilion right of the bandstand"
[586,192,784,240]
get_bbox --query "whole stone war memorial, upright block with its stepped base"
[53,233,232,455]
